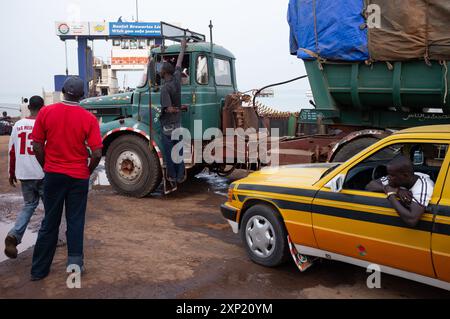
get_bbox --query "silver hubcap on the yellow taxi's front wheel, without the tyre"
[245,215,275,258]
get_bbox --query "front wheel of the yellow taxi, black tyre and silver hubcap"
[241,204,289,267]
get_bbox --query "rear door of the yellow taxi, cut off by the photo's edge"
[431,145,450,282]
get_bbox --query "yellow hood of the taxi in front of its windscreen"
[239,163,339,187]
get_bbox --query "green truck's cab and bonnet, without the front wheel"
[81,42,237,134]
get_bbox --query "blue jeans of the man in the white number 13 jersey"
[8,179,44,244]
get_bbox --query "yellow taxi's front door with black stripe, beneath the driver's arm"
[312,141,445,277]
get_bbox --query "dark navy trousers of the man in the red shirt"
[31,173,89,278]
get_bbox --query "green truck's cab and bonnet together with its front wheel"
[81,42,241,197]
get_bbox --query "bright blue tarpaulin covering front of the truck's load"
[288,0,369,61]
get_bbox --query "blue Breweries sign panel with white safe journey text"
[109,22,161,37]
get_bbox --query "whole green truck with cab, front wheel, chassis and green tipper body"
[82,23,450,197]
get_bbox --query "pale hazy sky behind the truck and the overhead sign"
[0,0,309,108]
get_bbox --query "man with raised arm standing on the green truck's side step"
[159,40,186,191]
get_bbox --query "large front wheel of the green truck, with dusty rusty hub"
[105,135,162,198]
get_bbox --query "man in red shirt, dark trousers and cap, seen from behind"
[31,77,103,280]
